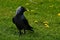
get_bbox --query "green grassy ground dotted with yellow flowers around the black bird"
[0,0,60,40]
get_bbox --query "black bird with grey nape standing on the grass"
[12,6,33,34]
